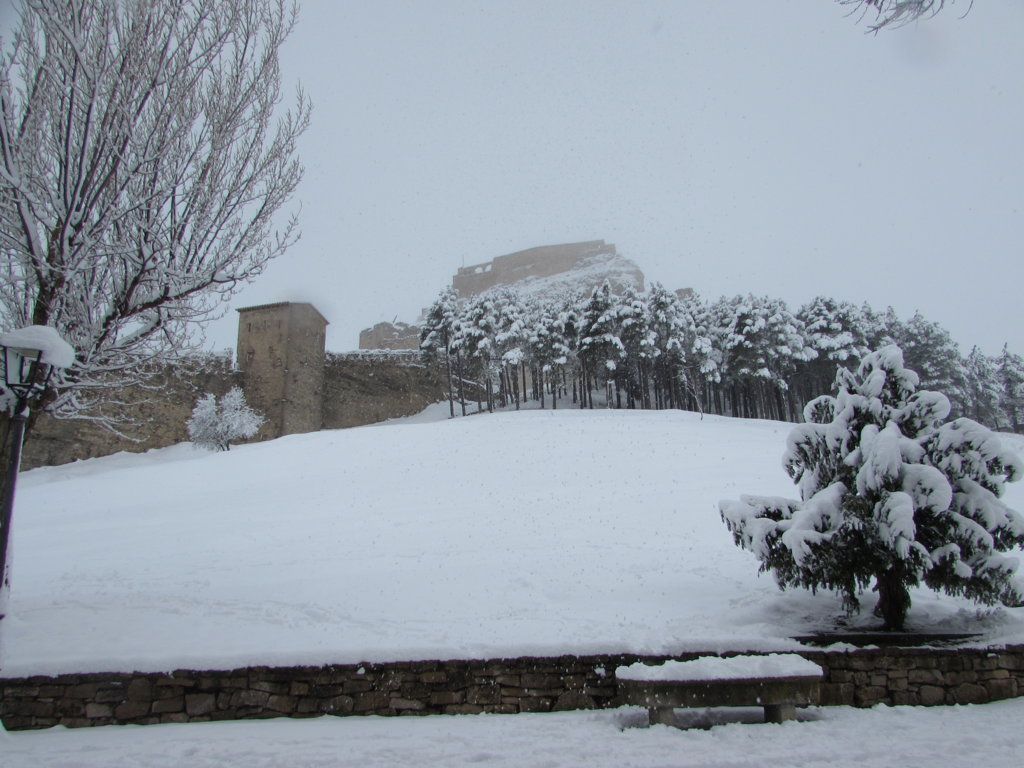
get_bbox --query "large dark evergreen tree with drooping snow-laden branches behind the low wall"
[719,345,1024,629]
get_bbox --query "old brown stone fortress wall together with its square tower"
[23,302,445,469]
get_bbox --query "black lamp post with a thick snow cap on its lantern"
[0,326,75,618]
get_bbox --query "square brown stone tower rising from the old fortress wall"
[237,301,328,439]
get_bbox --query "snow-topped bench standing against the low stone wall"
[615,653,823,725]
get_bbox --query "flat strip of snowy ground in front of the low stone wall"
[6,698,1024,768]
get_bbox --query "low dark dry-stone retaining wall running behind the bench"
[0,646,1024,730]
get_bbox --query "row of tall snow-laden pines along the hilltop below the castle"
[420,283,1024,432]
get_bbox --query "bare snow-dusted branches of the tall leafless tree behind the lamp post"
[0,0,309,434]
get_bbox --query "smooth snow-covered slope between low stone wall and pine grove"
[6,406,1024,677]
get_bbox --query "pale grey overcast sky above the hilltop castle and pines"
[83,0,1024,352]
